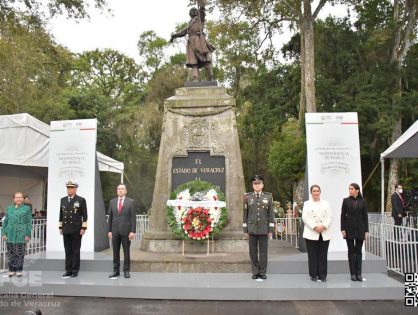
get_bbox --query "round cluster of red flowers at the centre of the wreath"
[182,207,212,240]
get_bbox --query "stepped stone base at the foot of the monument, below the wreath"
[136,230,251,273]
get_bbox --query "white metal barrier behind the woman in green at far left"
[0,219,46,270]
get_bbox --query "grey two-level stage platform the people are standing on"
[0,240,404,301]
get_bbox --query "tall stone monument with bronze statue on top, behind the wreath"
[139,0,250,272]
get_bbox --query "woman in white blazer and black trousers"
[302,185,332,282]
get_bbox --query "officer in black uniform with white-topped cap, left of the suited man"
[59,181,87,278]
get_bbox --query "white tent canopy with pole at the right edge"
[380,120,418,214]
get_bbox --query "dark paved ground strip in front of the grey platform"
[0,297,418,315]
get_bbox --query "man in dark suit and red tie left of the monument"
[108,184,136,279]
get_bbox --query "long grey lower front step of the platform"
[0,270,404,301]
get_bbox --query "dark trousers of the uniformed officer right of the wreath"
[249,234,268,275]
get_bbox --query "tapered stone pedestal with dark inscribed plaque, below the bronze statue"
[141,86,248,269]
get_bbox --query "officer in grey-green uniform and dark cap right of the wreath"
[242,175,274,279]
